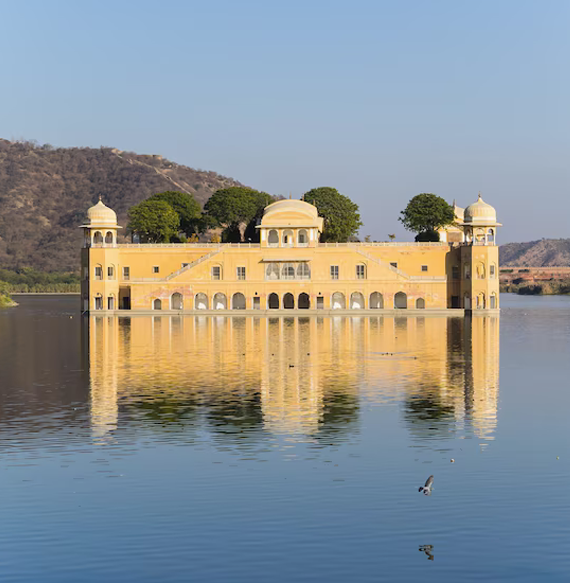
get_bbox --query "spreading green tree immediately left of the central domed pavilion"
[204,186,273,240]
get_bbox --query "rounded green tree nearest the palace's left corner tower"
[127,199,180,243]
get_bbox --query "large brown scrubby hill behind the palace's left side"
[0,139,240,272]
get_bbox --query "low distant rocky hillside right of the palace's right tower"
[499,239,570,267]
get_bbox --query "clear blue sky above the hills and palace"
[0,0,570,242]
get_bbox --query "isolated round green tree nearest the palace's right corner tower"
[399,192,455,241]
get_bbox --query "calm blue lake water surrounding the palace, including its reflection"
[0,296,570,583]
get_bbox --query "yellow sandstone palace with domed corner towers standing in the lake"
[81,196,501,313]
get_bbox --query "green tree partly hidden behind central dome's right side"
[303,186,362,243]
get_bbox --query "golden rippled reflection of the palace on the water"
[85,316,499,439]
